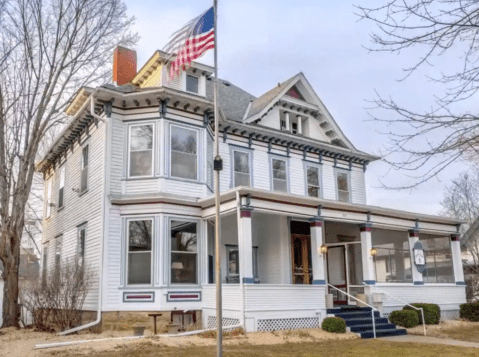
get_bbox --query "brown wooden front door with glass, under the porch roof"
[291,234,313,284]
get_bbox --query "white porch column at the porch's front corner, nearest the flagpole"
[238,207,254,284]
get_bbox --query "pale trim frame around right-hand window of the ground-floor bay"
[164,216,203,288]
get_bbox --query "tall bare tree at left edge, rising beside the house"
[0,0,138,327]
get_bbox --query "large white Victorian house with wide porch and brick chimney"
[38,48,465,331]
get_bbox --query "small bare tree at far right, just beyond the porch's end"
[441,169,479,301]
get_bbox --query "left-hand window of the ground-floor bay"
[127,219,153,285]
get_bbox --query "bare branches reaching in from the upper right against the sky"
[356,0,479,188]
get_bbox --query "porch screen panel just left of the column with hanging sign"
[372,229,412,283]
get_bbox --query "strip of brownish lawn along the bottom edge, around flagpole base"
[50,340,479,357]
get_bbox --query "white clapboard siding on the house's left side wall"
[43,123,105,310]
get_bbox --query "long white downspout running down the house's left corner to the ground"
[58,94,109,336]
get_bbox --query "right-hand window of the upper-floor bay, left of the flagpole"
[170,126,198,180]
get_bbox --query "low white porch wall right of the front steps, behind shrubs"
[372,284,466,312]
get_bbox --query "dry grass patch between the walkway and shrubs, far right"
[408,320,479,343]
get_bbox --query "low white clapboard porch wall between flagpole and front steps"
[244,284,326,312]
